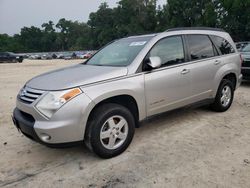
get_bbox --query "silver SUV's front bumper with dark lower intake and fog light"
[13,91,93,147]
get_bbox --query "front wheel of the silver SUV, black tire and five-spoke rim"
[84,103,135,159]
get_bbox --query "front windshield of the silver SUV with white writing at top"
[87,36,153,67]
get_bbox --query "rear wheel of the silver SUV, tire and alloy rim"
[211,79,234,112]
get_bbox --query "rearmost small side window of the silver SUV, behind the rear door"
[211,36,235,55]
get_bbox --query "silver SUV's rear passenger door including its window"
[185,34,222,102]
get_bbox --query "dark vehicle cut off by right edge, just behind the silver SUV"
[241,43,250,80]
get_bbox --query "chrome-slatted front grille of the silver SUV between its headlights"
[19,87,44,104]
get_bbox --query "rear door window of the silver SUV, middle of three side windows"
[187,35,215,60]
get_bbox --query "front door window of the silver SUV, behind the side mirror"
[148,36,185,66]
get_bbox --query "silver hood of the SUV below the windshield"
[26,64,128,91]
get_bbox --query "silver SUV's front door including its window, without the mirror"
[145,36,191,116]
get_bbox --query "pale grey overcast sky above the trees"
[0,0,166,35]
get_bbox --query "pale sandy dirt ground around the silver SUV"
[0,60,250,188]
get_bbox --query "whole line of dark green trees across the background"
[0,0,250,52]
